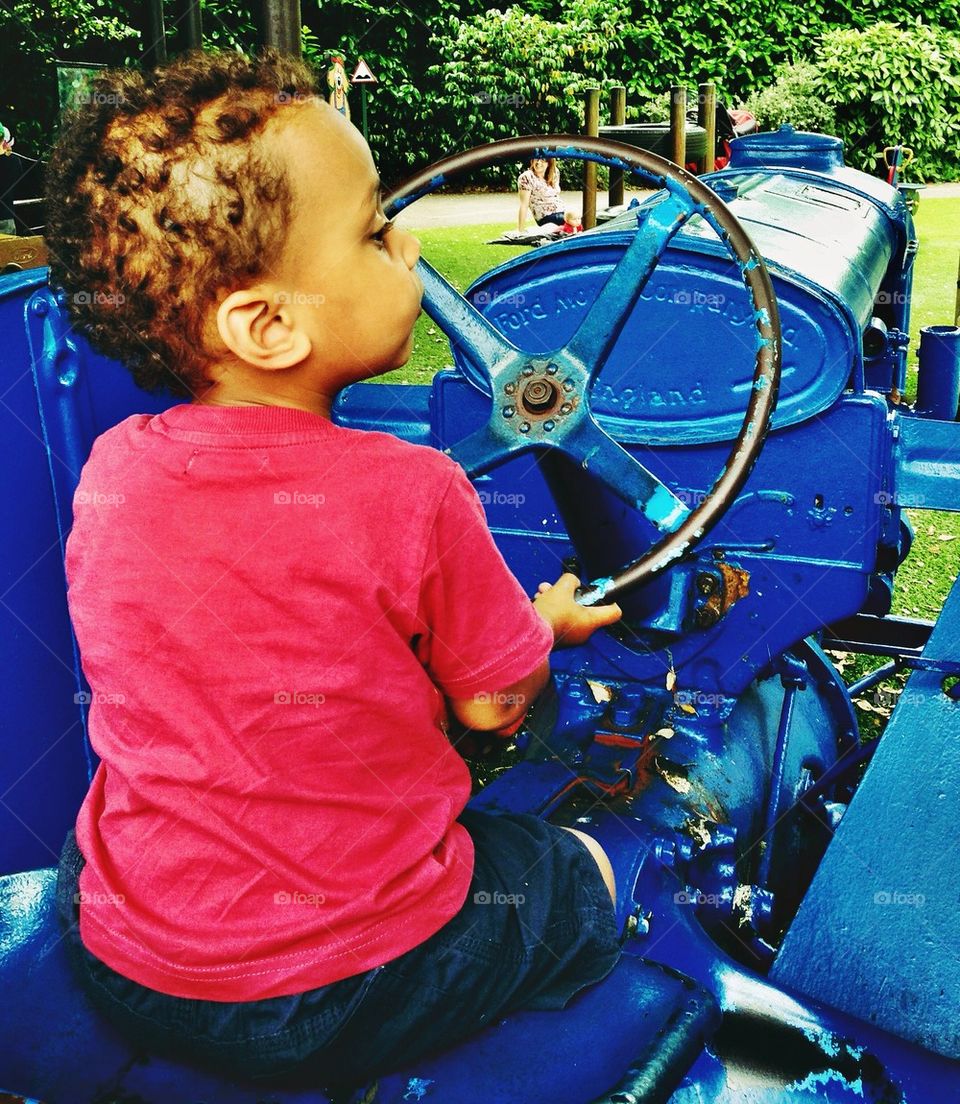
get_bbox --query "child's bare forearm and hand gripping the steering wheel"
[447,572,622,735]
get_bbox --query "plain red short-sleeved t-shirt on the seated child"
[66,405,553,1000]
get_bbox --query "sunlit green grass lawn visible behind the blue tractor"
[382,198,960,697]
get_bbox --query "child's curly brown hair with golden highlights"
[46,50,317,395]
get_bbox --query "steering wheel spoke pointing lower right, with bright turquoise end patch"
[557,415,690,535]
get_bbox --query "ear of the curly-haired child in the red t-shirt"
[216,287,311,370]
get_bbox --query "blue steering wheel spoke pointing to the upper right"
[566,192,696,381]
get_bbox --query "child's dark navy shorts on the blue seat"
[57,810,620,1093]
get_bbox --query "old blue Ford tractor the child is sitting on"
[0,130,960,1104]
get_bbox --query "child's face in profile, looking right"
[267,100,423,389]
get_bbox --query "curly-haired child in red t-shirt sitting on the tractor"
[47,52,620,1086]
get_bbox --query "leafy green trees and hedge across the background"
[0,0,960,184]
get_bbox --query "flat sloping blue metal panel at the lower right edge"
[771,581,960,1059]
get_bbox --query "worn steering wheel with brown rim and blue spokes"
[386,135,781,606]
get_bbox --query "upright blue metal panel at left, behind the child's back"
[0,269,170,872]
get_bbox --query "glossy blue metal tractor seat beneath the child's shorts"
[0,869,718,1104]
